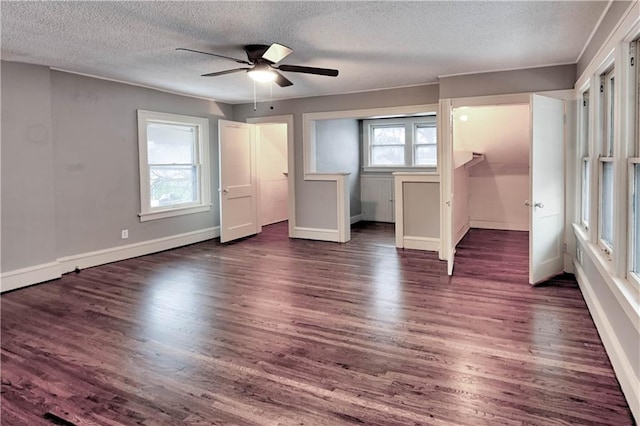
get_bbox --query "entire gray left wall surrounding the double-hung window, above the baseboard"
[1,62,231,271]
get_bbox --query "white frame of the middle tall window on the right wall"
[598,67,616,255]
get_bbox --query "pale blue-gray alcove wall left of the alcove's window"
[316,119,362,216]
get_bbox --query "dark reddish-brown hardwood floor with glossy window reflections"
[0,223,633,425]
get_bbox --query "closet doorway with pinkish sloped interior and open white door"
[441,94,565,284]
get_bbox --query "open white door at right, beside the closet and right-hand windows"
[525,95,564,284]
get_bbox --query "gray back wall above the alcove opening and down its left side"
[233,84,439,229]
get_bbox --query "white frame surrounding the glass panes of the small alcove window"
[362,114,440,173]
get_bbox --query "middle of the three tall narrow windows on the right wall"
[598,69,615,255]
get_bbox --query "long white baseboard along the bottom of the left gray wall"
[0,226,220,292]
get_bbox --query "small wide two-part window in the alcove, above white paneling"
[363,115,438,169]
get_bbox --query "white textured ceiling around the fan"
[1,0,608,103]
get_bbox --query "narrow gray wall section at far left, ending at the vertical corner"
[1,62,57,271]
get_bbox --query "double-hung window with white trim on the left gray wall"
[138,110,211,221]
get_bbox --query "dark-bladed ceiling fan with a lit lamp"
[176,43,338,87]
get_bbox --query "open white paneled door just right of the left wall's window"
[218,120,258,243]
